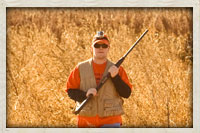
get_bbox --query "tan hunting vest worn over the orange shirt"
[78,59,124,117]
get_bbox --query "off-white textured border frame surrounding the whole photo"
[0,0,200,133]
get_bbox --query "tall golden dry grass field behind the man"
[7,8,193,127]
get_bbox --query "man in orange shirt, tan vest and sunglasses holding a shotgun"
[66,31,132,127]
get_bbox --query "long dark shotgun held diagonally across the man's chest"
[74,29,148,114]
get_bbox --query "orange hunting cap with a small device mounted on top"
[92,31,110,46]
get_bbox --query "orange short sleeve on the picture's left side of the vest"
[66,66,80,92]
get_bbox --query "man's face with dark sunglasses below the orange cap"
[92,42,109,59]
